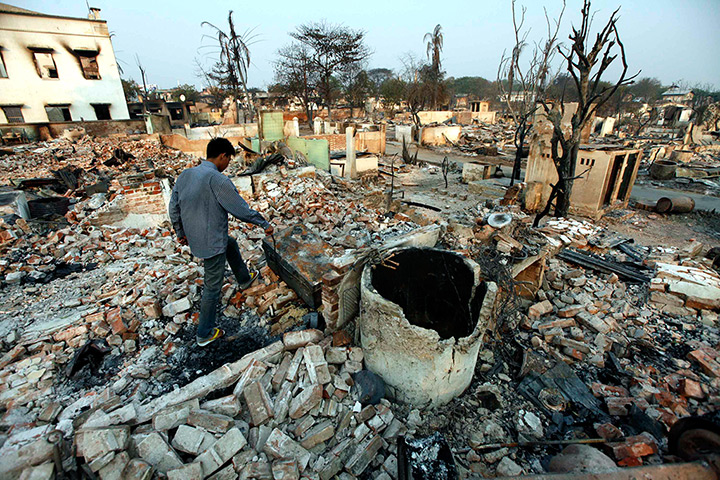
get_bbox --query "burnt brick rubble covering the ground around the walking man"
[0,133,720,480]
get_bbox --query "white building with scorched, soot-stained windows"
[0,3,130,125]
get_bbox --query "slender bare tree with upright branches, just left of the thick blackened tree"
[497,0,565,185]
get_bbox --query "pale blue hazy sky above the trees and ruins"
[15,0,720,88]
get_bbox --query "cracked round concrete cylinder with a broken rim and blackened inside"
[358,248,497,406]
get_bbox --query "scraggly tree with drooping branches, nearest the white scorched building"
[201,10,255,121]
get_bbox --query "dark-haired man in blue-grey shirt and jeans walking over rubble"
[168,138,273,347]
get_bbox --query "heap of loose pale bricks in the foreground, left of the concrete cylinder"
[5,330,408,480]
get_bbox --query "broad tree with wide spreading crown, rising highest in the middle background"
[290,21,371,119]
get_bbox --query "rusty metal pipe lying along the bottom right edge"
[496,455,720,480]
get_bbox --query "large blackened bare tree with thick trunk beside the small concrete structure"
[535,0,640,220]
